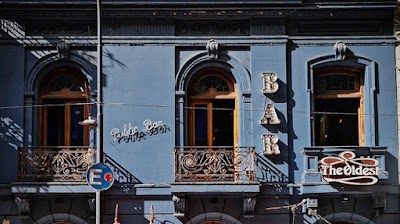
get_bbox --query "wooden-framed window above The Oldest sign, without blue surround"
[313,66,365,146]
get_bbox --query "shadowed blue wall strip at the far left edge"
[0,46,24,183]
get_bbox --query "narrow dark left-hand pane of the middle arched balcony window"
[194,104,208,146]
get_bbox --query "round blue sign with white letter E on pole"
[86,163,114,191]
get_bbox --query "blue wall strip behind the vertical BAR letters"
[250,44,290,177]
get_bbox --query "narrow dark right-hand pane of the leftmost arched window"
[70,105,85,146]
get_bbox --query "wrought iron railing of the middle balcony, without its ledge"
[175,146,256,182]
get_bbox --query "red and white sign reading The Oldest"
[319,151,379,185]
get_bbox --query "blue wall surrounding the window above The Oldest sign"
[290,40,398,183]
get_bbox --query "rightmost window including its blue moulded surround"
[308,55,377,146]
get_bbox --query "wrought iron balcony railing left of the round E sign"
[17,146,95,182]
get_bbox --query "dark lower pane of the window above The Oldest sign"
[315,99,359,146]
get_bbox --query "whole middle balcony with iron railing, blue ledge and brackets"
[171,146,260,217]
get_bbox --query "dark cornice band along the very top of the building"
[0,1,395,22]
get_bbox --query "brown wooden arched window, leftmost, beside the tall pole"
[39,67,90,146]
